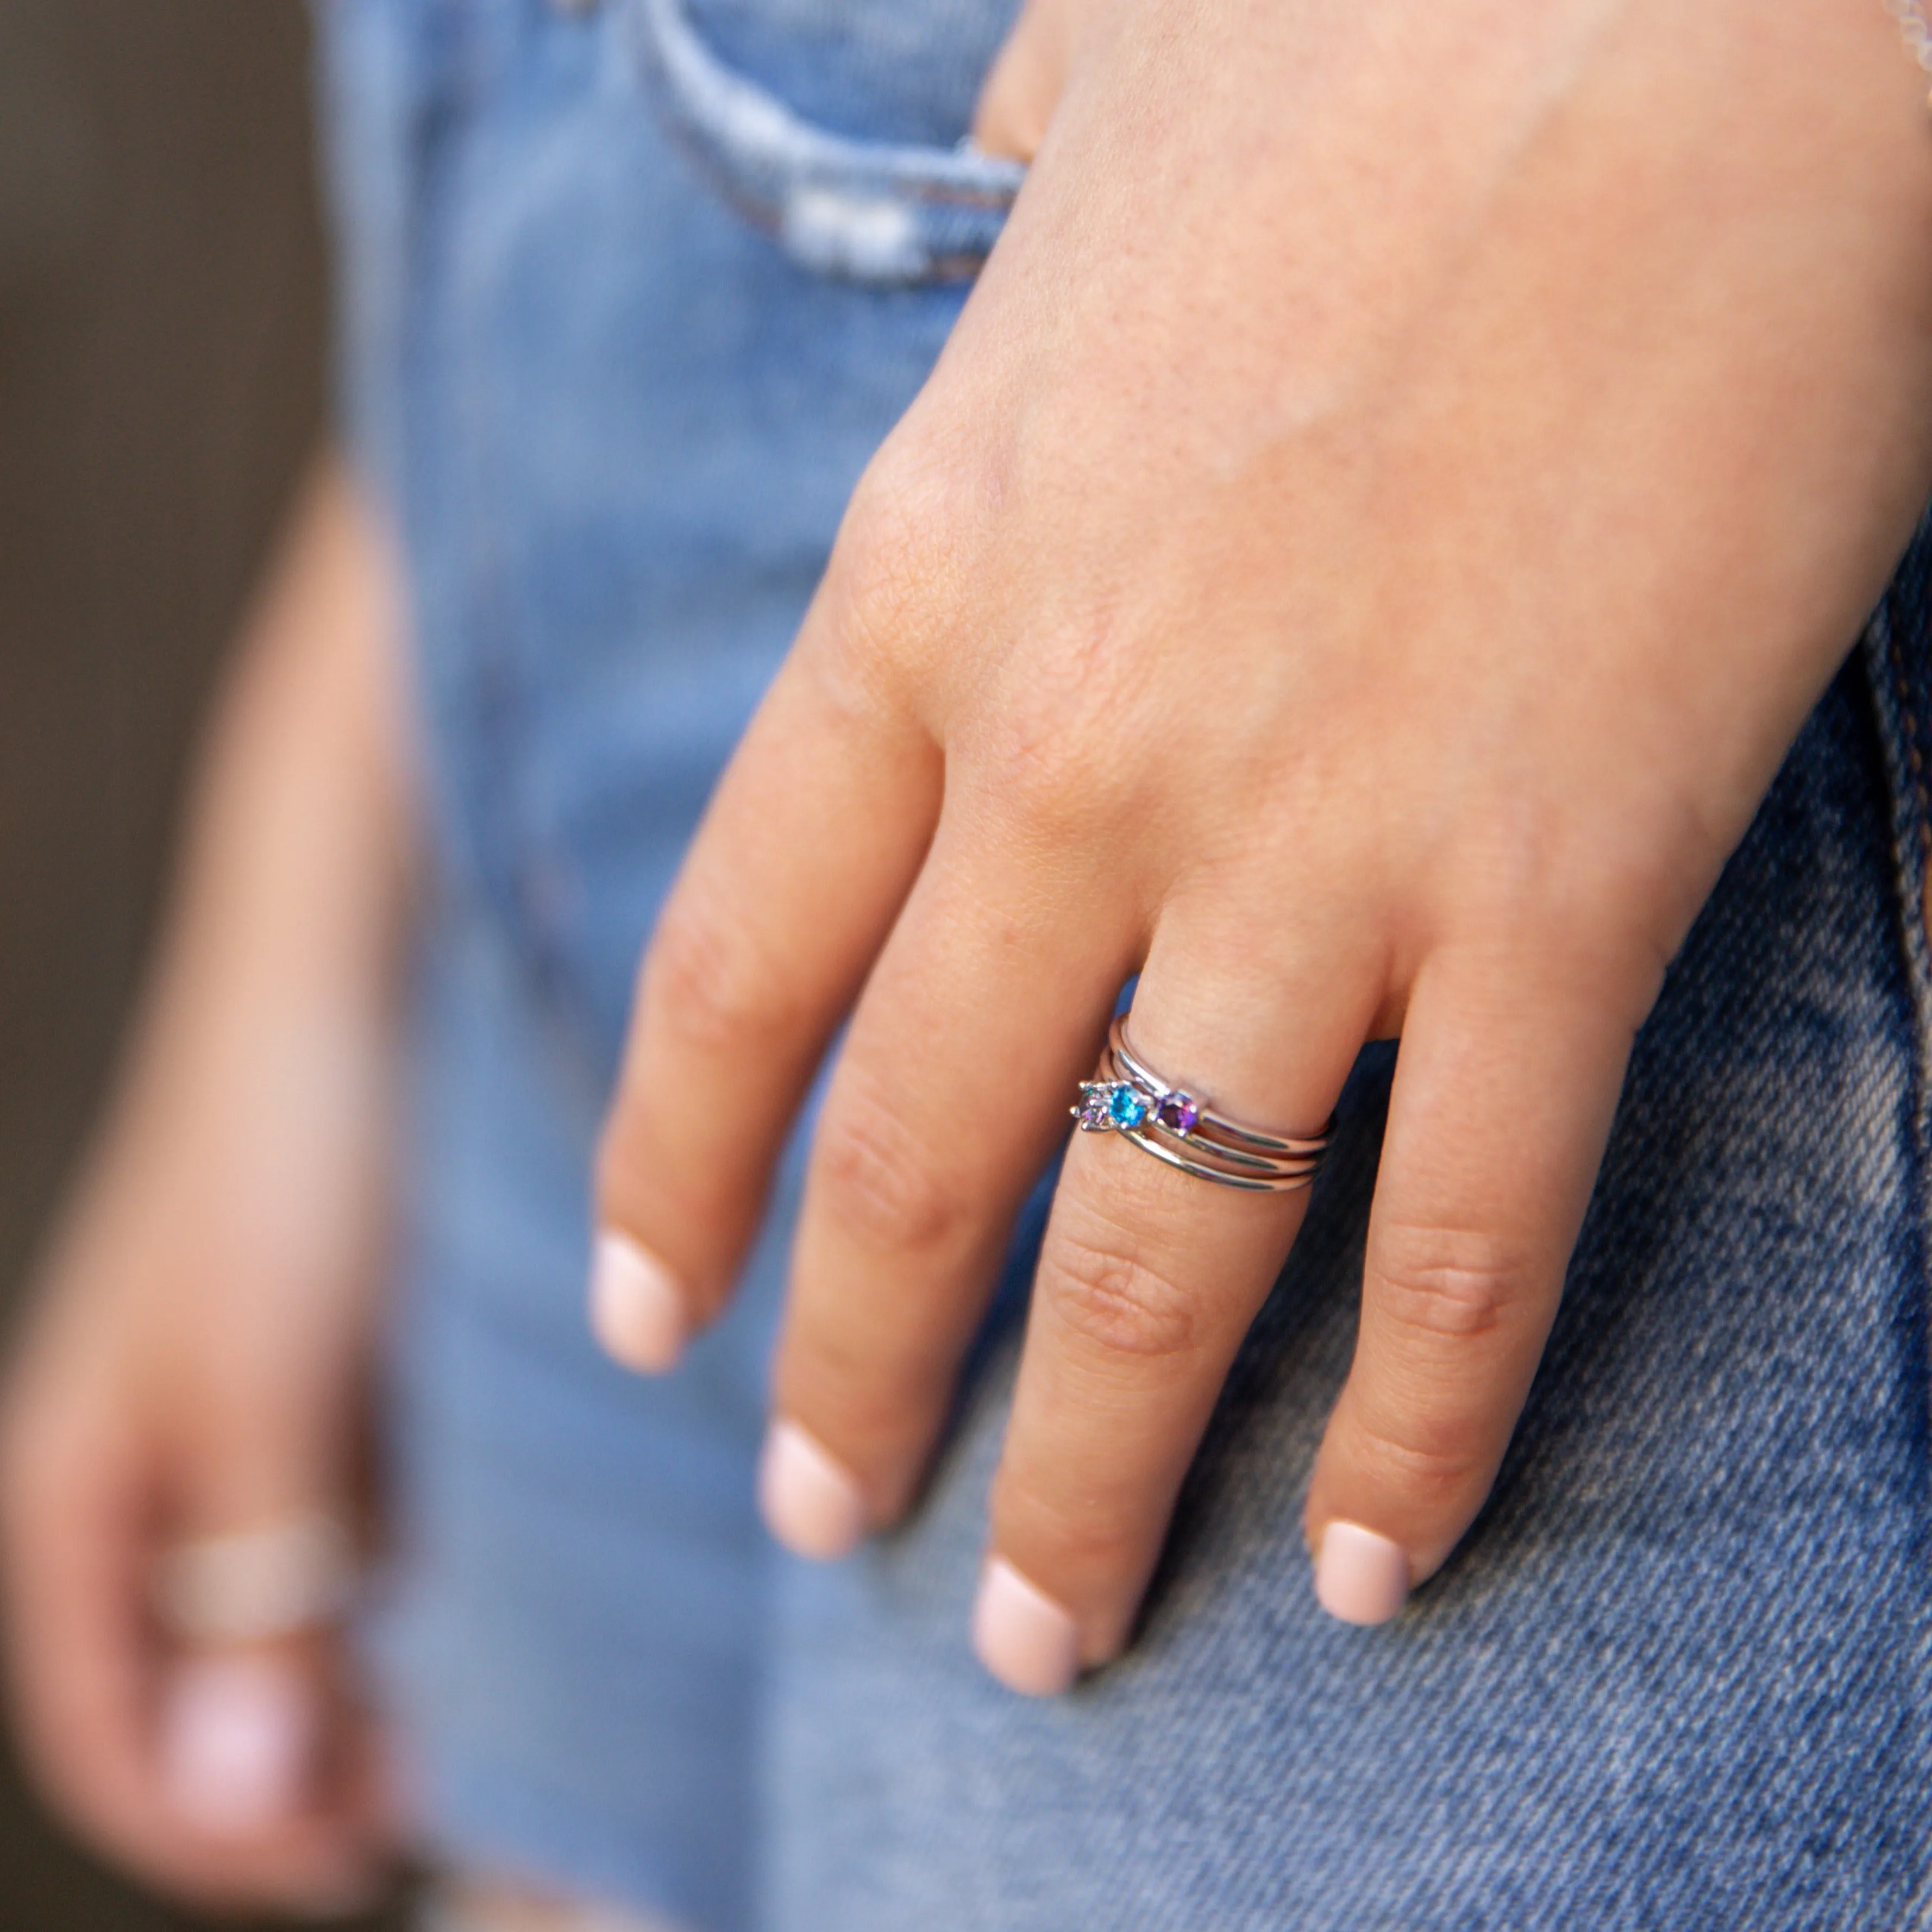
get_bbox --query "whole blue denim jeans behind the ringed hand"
[319,0,1932,1932]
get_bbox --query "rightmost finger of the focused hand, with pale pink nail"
[1304,956,1633,1623]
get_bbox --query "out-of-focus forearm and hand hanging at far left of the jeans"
[0,456,411,1911]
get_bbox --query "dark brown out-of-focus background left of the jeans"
[0,0,396,1932]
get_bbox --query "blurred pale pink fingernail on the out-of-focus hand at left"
[159,1658,315,1837]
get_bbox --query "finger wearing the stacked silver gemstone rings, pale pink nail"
[974,918,1379,1695]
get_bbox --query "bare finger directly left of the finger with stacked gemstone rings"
[760,819,1138,1557]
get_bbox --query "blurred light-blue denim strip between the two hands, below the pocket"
[317,0,1008,1932]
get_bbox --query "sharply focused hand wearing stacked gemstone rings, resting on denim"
[597,0,1932,1691]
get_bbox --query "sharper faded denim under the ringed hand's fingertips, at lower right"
[767,606,1932,1932]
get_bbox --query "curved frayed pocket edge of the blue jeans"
[626,0,1026,286]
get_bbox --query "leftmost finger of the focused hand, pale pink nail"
[591,576,941,1370]
